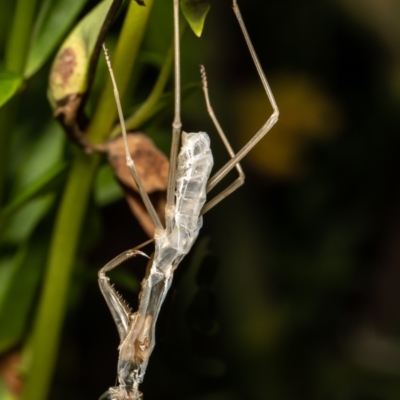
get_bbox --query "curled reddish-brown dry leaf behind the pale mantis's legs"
[102,133,169,237]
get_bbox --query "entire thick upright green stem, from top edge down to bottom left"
[22,0,153,400]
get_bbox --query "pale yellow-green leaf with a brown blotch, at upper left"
[48,0,113,108]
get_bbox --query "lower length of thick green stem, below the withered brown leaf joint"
[22,153,100,400]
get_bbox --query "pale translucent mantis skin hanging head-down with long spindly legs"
[99,0,279,400]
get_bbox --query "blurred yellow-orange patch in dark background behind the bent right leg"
[233,75,342,179]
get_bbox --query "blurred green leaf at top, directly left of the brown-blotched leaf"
[24,0,87,78]
